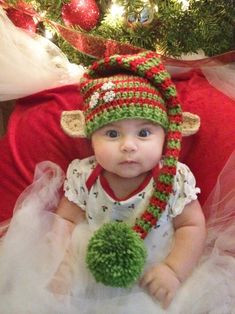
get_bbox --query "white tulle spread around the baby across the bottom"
[0,153,235,314]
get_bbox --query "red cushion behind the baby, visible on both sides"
[0,71,235,221]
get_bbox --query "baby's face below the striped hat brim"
[92,119,165,178]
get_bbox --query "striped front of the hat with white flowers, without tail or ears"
[81,72,168,137]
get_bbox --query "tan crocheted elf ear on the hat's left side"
[60,110,86,137]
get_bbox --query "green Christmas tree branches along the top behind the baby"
[3,0,235,65]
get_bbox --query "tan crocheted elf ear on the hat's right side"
[182,111,201,136]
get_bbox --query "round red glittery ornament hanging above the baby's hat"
[62,0,100,31]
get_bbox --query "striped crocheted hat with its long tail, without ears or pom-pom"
[81,51,182,238]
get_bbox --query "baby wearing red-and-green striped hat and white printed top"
[57,52,206,308]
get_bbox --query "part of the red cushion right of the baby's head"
[175,71,235,214]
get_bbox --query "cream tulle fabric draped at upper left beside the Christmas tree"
[0,6,84,101]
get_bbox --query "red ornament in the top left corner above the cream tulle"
[6,1,38,33]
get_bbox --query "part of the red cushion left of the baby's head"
[0,85,92,221]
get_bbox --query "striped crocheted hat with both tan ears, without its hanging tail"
[61,52,200,137]
